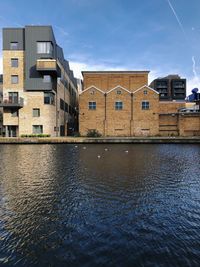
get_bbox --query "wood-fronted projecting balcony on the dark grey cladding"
[36,59,61,77]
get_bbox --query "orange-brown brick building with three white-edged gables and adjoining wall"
[79,71,200,137]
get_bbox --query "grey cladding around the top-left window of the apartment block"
[3,28,25,50]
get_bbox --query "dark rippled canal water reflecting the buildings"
[0,144,200,267]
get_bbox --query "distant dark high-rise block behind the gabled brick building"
[150,75,186,101]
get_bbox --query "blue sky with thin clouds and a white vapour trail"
[0,0,200,94]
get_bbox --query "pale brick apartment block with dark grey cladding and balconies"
[0,26,78,137]
